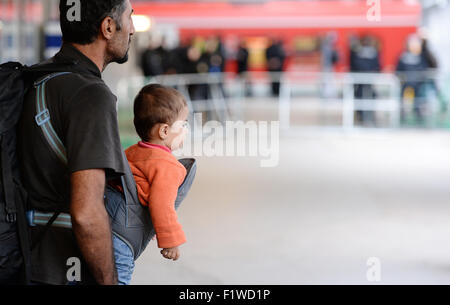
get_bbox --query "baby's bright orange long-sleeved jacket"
[125,142,186,248]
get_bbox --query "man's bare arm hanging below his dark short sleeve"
[70,169,117,285]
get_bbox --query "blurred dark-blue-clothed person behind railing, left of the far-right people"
[350,35,381,125]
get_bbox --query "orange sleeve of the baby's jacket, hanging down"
[148,161,186,248]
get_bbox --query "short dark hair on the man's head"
[59,0,127,45]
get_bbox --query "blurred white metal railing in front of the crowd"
[117,72,446,130]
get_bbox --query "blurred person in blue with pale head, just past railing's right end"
[396,34,430,123]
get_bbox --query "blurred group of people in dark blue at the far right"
[350,33,447,125]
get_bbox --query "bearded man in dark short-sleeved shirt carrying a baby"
[18,0,134,285]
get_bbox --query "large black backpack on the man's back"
[0,62,75,285]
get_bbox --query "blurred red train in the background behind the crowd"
[132,0,421,71]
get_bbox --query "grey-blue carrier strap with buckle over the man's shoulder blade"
[34,72,71,165]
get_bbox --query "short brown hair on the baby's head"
[134,84,187,142]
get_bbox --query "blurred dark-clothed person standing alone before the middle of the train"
[266,39,286,97]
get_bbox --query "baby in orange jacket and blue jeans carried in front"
[113,84,189,284]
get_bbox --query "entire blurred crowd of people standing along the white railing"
[140,32,446,124]
